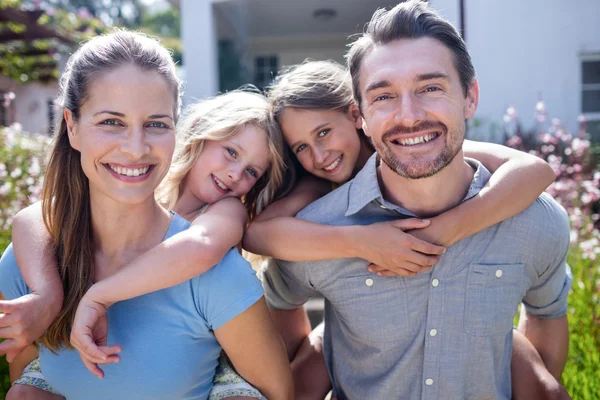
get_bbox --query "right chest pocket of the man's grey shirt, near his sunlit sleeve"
[465,264,525,336]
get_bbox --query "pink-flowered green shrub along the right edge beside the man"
[504,102,600,400]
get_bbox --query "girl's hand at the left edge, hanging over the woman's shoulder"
[0,293,62,362]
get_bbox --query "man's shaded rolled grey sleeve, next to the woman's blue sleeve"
[258,258,318,310]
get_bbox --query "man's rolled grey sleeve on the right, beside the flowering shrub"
[523,196,572,319]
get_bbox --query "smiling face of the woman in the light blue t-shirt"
[64,65,175,204]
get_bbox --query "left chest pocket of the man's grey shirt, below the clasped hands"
[331,273,409,343]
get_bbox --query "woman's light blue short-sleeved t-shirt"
[0,215,263,400]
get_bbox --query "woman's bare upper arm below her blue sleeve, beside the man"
[215,297,294,400]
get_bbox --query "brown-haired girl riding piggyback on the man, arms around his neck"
[243,61,554,398]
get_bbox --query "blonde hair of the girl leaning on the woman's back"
[158,90,285,220]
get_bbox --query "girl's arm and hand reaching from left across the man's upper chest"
[243,178,444,274]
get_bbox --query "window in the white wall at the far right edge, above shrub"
[581,55,600,143]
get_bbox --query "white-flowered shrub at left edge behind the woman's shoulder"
[0,124,50,251]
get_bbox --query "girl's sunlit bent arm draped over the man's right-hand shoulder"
[400,140,555,246]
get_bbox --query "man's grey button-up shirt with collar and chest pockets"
[262,156,571,400]
